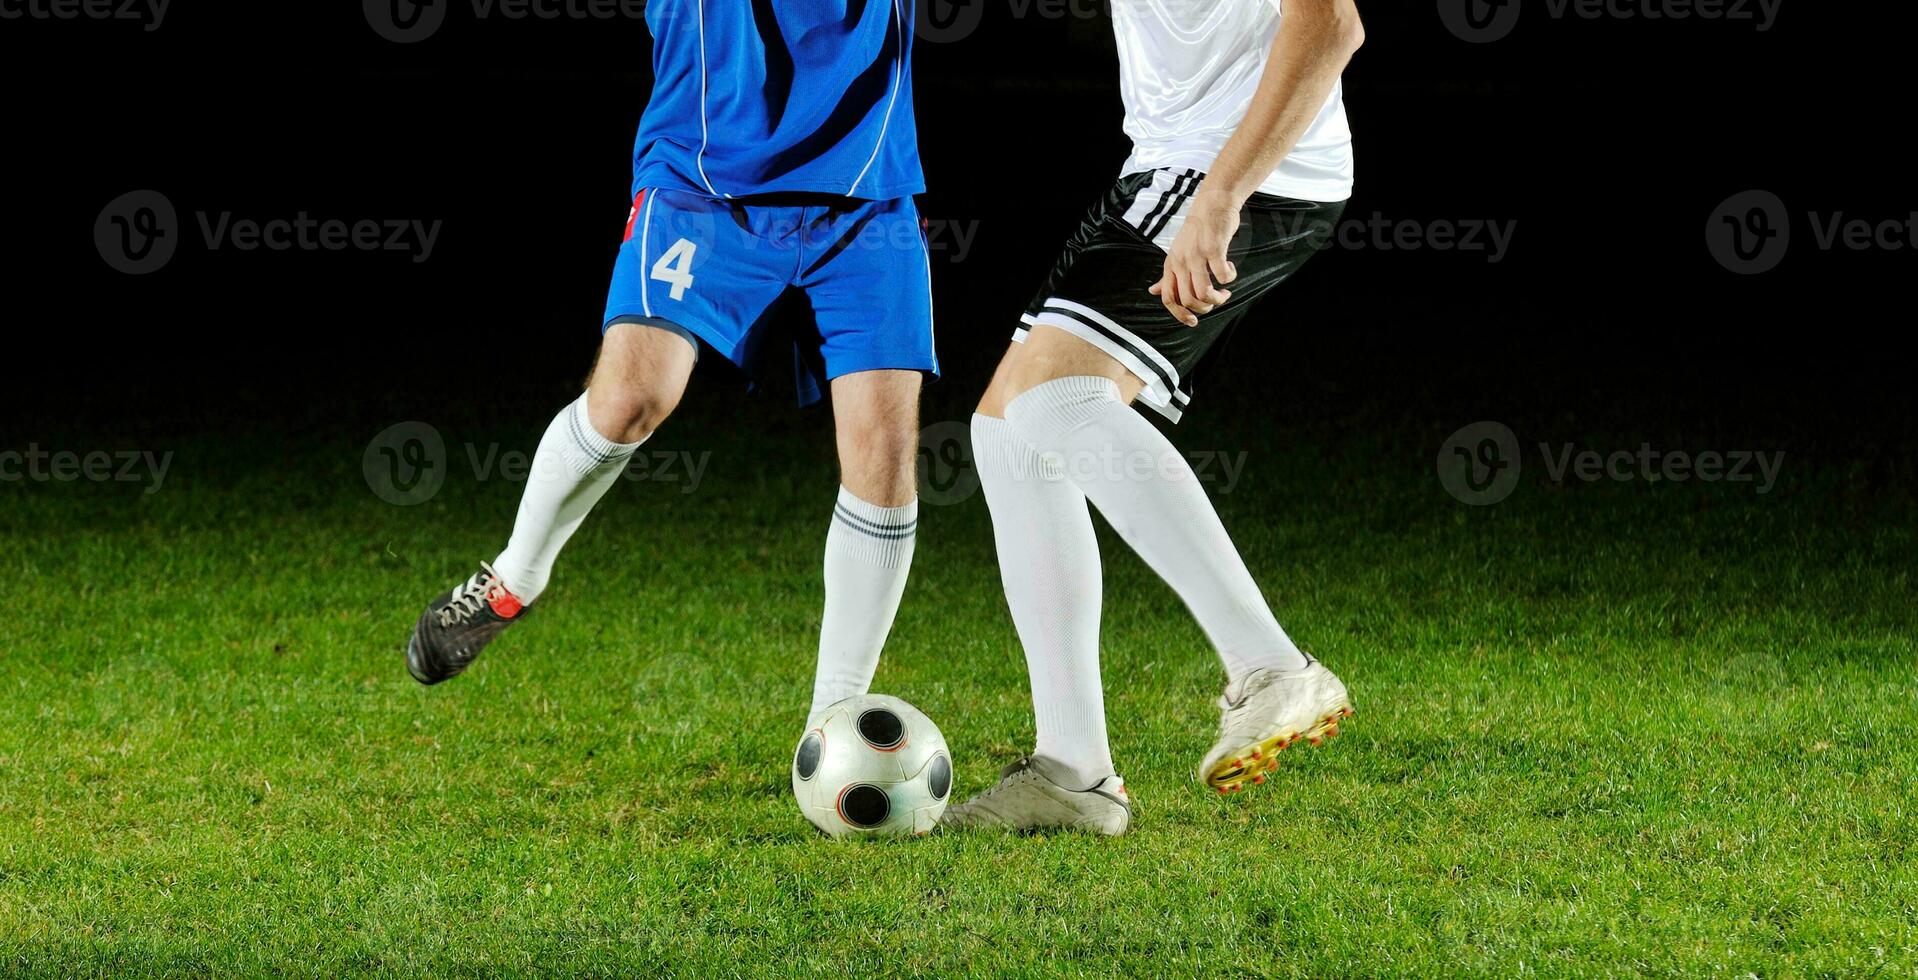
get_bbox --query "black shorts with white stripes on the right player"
[1013,169,1345,422]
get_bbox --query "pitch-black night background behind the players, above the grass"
[0,0,1918,445]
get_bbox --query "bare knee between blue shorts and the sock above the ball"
[832,368,923,506]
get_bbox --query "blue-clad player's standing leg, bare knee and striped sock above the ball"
[809,370,921,717]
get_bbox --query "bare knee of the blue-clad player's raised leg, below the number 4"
[587,320,698,441]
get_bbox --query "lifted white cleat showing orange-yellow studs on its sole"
[1199,654,1352,792]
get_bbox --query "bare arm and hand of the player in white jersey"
[1151,0,1366,326]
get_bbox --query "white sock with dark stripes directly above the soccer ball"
[807,487,919,719]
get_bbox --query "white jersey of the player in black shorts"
[1112,0,1352,201]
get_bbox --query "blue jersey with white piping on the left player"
[633,0,926,201]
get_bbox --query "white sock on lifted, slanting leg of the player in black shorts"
[1005,378,1306,681]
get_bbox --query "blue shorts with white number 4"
[600,188,940,405]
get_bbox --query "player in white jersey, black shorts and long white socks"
[946,0,1364,834]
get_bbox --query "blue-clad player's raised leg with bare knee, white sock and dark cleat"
[407,322,696,685]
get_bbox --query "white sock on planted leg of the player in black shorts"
[972,414,1112,788]
